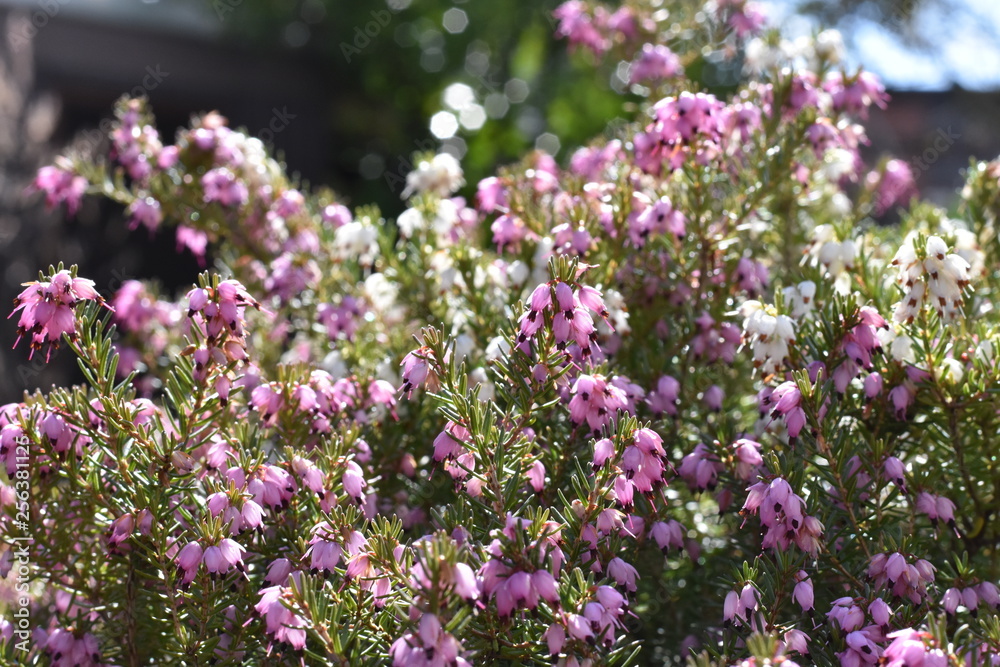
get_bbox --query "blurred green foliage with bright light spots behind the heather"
[219,0,622,214]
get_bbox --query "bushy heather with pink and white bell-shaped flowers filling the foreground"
[0,0,1000,667]
